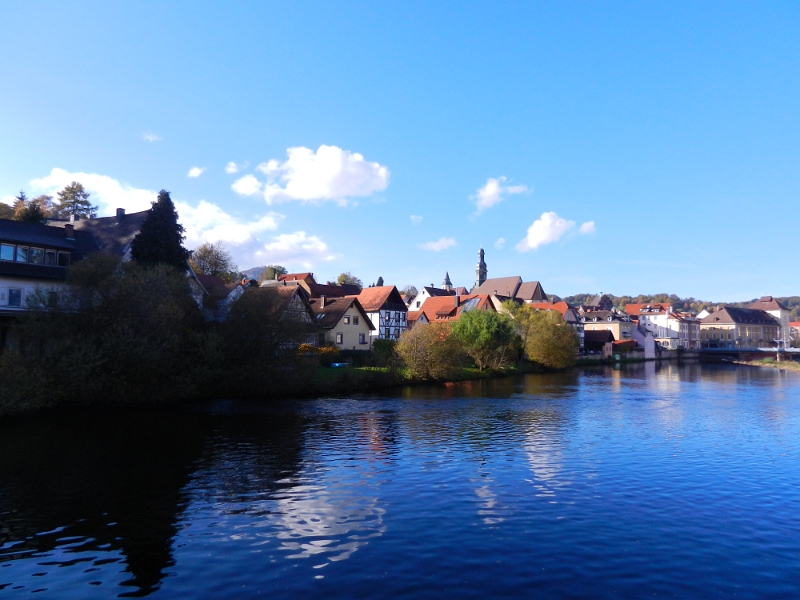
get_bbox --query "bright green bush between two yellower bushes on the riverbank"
[453,310,519,371]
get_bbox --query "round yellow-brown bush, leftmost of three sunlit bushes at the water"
[395,323,465,380]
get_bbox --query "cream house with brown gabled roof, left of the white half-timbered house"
[309,296,375,350]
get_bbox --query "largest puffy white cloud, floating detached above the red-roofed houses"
[232,145,389,204]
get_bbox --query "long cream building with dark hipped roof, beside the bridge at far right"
[700,306,781,348]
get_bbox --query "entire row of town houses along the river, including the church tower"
[0,209,800,356]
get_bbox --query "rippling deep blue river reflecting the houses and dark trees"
[0,363,800,599]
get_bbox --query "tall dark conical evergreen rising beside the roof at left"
[131,190,189,269]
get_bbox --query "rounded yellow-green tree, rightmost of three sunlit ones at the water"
[514,304,580,369]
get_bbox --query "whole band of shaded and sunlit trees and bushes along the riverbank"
[0,190,578,414]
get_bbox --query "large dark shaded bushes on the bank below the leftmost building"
[0,254,218,410]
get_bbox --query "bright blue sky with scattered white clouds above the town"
[0,0,800,301]
